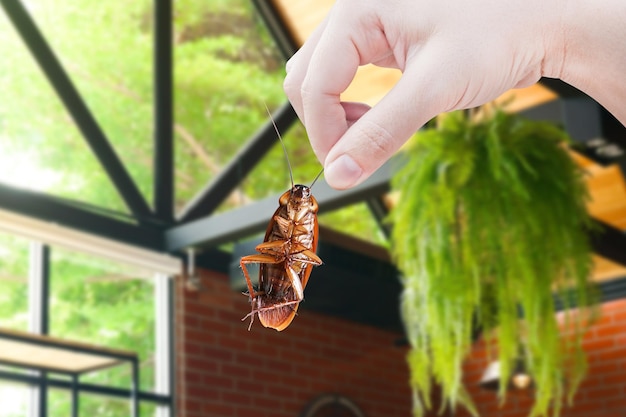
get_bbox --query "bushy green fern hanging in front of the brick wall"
[391,111,594,416]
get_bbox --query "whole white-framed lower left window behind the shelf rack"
[0,242,172,417]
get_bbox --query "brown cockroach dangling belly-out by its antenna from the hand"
[239,110,322,331]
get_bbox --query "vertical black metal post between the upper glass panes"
[153,0,174,223]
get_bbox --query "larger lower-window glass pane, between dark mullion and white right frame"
[50,248,155,392]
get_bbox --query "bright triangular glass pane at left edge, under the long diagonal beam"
[0,2,125,214]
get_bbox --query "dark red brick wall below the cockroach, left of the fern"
[176,272,411,417]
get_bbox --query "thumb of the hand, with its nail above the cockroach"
[324,52,445,189]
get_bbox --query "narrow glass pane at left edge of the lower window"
[0,233,29,331]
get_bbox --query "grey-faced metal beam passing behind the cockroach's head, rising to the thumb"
[165,157,403,252]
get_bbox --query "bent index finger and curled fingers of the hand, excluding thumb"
[285,0,397,162]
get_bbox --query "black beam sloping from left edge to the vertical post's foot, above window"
[0,184,163,251]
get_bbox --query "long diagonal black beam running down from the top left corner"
[2,0,152,219]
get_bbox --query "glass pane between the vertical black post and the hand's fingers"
[175,0,287,213]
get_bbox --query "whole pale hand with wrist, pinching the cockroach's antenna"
[284,0,626,189]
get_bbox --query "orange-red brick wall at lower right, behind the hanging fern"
[456,300,626,417]
